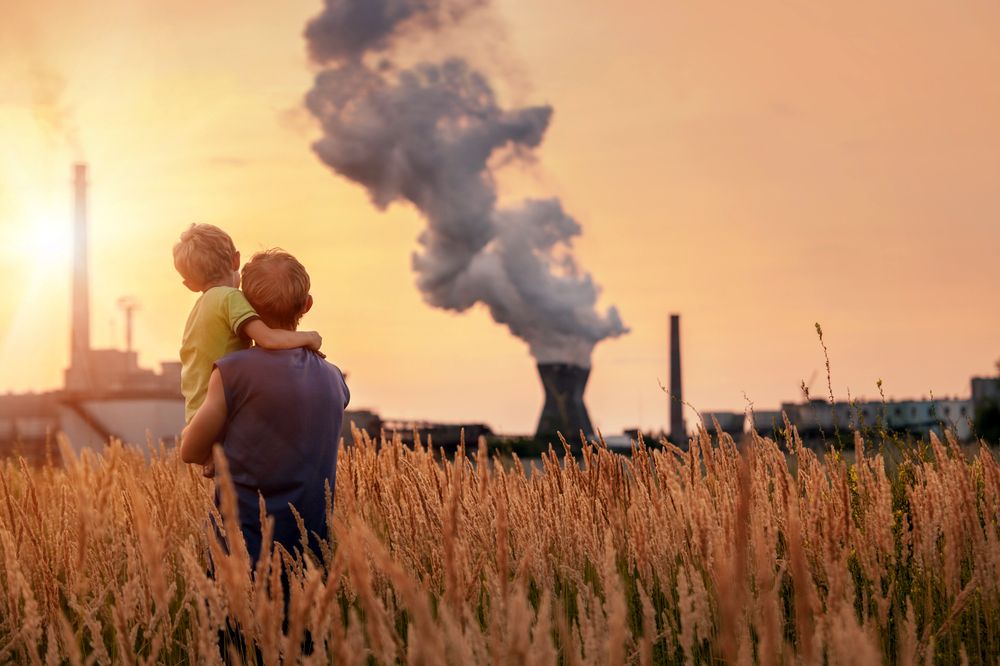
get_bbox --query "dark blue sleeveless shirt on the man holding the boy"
[215,347,351,562]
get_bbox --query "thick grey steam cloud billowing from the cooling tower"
[305,0,628,367]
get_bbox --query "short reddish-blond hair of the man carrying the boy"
[242,248,310,329]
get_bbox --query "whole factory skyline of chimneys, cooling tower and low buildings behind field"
[0,164,1000,463]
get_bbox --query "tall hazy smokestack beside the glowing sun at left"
[70,162,90,388]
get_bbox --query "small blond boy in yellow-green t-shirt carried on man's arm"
[174,224,323,473]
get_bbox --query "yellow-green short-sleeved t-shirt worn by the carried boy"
[181,287,257,423]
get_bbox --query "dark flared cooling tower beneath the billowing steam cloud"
[535,363,594,442]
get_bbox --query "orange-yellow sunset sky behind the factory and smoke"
[0,0,1000,433]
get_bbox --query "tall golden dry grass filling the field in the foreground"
[0,426,1000,664]
